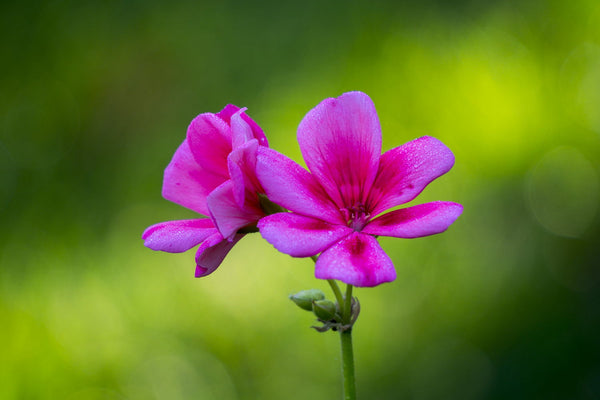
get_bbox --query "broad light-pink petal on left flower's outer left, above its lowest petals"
[162,140,225,215]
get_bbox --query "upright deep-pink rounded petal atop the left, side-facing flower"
[186,110,232,180]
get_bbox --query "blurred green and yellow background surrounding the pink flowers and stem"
[0,0,600,400]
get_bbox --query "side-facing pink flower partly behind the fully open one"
[142,104,268,277]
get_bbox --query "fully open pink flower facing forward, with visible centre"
[256,92,462,286]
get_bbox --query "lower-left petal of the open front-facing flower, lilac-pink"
[258,213,352,257]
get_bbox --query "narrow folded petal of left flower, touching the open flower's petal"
[227,138,263,208]
